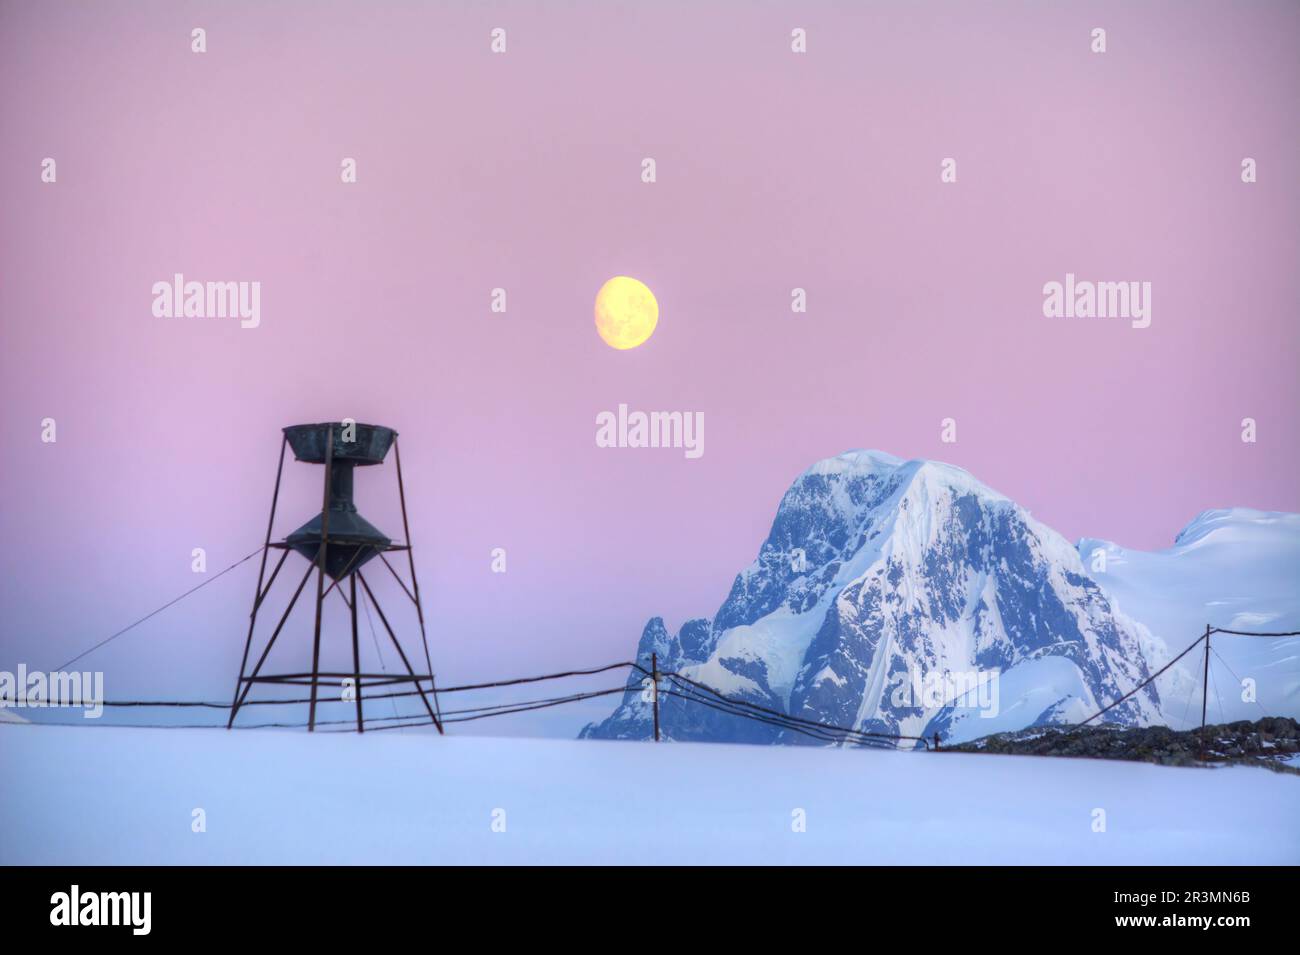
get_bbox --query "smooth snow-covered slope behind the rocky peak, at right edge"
[1078,508,1300,729]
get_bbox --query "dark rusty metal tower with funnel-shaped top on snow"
[226,421,442,733]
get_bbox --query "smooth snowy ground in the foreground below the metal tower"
[0,725,1300,865]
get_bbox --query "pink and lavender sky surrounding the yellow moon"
[0,3,1300,695]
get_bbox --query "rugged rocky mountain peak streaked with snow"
[582,451,1165,743]
